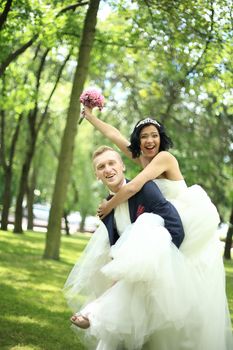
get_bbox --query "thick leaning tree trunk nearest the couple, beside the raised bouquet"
[44,0,100,260]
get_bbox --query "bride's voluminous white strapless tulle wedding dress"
[64,179,233,350]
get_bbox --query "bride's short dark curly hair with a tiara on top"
[128,118,173,158]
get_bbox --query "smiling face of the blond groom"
[93,150,125,192]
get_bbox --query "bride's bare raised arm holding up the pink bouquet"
[83,106,140,164]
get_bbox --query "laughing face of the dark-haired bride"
[140,125,160,158]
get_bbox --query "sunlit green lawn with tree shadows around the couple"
[0,231,233,350]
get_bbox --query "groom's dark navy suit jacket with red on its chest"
[103,181,184,248]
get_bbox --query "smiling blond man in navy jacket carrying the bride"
[93,146,184,248]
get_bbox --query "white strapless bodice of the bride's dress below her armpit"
[154,179,187,200]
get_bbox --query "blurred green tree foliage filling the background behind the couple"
[0,0,233,224]
